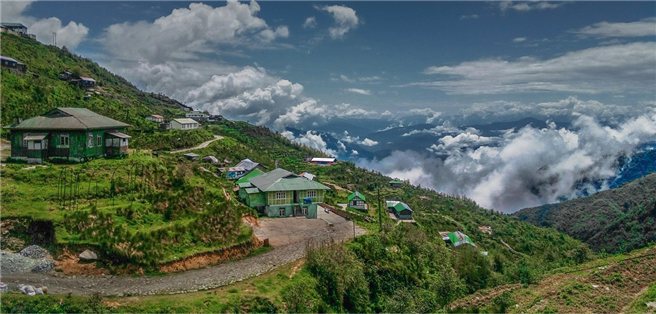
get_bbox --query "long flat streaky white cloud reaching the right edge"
[416,42,656,94]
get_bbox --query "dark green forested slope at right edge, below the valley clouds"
[514,174,656,252]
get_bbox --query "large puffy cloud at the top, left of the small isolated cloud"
[102,0,289,63]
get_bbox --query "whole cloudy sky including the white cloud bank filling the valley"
[0,0,656,212]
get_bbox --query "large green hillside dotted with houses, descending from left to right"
[0,34,604,312]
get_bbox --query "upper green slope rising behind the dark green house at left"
[0,33,212,150]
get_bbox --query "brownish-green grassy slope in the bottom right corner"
[453,246,656,313]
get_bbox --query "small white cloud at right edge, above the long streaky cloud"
[572,17,656,37]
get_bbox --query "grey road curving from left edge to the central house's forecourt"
[2,211,365,296]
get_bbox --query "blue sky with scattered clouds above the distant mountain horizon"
[2,0,656,127]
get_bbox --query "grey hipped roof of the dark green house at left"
[10,108,130,130]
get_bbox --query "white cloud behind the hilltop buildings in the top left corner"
[2,0,89,50]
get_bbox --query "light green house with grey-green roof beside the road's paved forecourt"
[237,168,330,218]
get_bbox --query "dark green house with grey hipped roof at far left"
[5,108,130,163]
